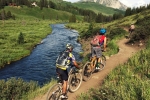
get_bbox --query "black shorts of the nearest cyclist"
[56,68,68,81]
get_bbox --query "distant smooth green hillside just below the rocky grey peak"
[73,2,124,15]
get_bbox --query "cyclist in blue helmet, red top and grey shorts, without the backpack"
[91,28,106,69]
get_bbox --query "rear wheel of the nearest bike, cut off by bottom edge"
[46,83,62,100]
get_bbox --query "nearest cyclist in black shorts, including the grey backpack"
[56,43,79,99]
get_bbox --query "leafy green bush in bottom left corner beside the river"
[0,78,38,100]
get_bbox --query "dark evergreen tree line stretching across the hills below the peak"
[0,0,150,23]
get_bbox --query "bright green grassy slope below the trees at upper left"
[1,6,79,20]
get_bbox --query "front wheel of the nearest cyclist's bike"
[68,73,82,92]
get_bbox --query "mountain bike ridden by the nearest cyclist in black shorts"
[46,67,82,100]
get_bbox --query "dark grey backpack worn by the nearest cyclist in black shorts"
[56,51,69,68]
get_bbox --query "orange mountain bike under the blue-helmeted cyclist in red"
[82,52,106,81]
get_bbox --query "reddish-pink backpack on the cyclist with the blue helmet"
[90,35,105,46]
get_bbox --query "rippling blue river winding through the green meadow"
[0,24,82,85]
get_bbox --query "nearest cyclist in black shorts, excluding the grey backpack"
[56,43,79,99]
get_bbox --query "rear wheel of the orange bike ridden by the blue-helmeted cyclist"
[82,62,92,81]
